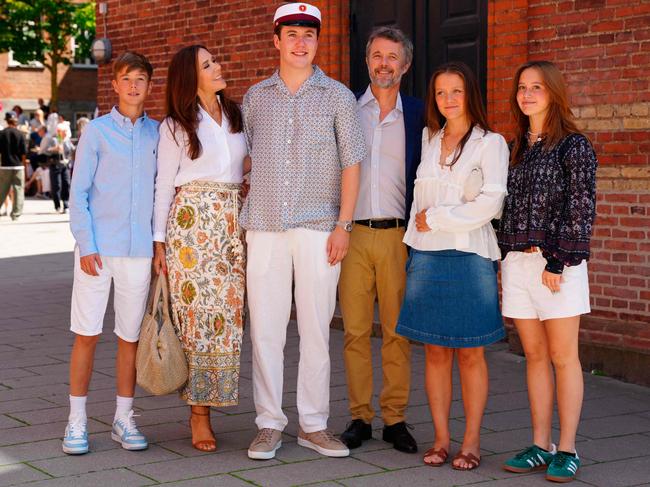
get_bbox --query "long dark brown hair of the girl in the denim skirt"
[425,61,490,166]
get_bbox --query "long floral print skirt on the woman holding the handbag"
[167,181,246,406]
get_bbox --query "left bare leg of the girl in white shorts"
[514,319,553,450]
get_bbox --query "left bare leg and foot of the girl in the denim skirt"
[424,345,454,463]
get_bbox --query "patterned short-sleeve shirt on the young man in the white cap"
[240,66,366,232]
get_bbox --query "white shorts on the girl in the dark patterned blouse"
[501,252,591,321]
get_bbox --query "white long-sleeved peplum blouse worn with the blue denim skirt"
[404,127,509,260]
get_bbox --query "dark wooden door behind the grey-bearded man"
[350,0,487,100]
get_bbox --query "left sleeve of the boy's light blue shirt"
[70,125,99,257]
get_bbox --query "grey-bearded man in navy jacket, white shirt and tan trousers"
[339,27,424,453]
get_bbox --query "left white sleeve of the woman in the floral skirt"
[153,120,185,242]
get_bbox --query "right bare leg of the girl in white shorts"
[544,316,584,452]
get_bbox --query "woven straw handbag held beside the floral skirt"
[136,272,188,396]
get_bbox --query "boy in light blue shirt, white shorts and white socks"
[63,52,158,455]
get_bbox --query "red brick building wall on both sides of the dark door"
[98,0,650,342]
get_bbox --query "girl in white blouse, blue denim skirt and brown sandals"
[397,63,508,470]
